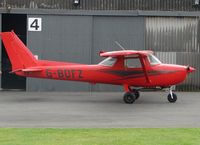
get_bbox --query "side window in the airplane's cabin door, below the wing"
[124,58,142,68]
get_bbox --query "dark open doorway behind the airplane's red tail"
[1,14,27,90]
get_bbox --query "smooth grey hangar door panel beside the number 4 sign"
[27,15,92,91]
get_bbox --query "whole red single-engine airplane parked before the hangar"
[1,31,195,104]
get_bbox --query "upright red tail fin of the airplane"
[1,31,37,72]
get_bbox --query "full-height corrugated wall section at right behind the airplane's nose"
[145,17,200,91]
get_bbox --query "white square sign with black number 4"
[28,18,42,31]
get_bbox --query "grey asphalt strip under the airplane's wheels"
[0,91,200,128]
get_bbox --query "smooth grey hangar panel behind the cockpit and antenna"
[92,16,144,91]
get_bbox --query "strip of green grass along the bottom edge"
[0,128,200,145]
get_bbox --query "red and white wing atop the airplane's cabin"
[100,50,153,57]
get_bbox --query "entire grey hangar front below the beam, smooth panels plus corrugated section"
[0,15,197,91]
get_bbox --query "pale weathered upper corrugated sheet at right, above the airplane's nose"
[145,17,200,52]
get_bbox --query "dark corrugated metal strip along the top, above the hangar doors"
[0,0,197,11]
